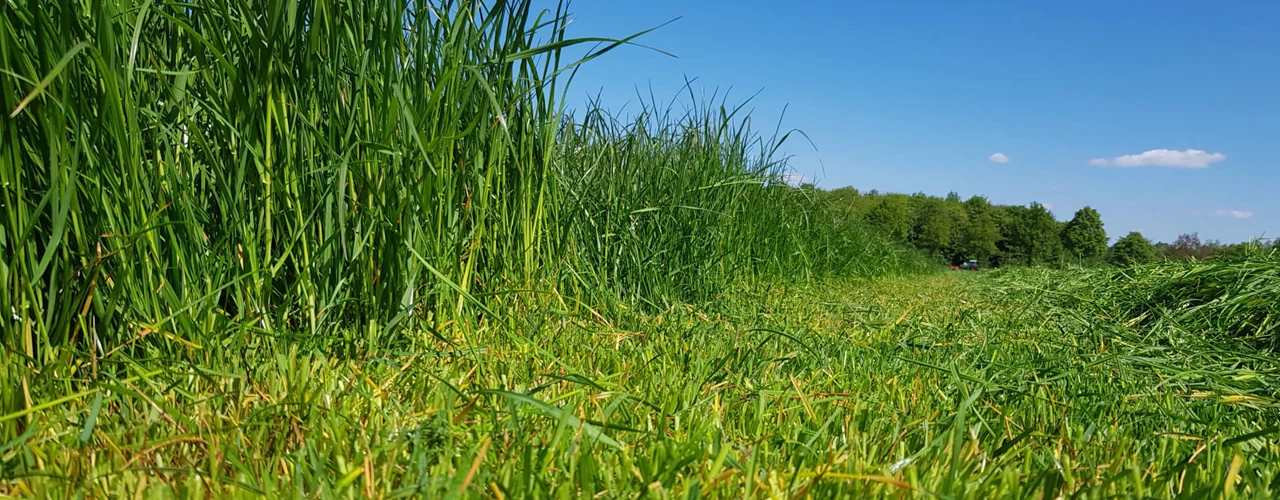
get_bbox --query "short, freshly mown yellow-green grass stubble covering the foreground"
[4,260,1280,499]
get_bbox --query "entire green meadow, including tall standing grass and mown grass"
[0,0,1280,499]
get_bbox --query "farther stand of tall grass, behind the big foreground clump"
[558,96,924,304]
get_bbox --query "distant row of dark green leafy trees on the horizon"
[800,184,1276,267]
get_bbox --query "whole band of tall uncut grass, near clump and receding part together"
[0,0,916,367]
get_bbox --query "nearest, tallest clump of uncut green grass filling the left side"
[0,0,599,362]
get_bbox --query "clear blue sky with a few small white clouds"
[558,0,1280,242]
